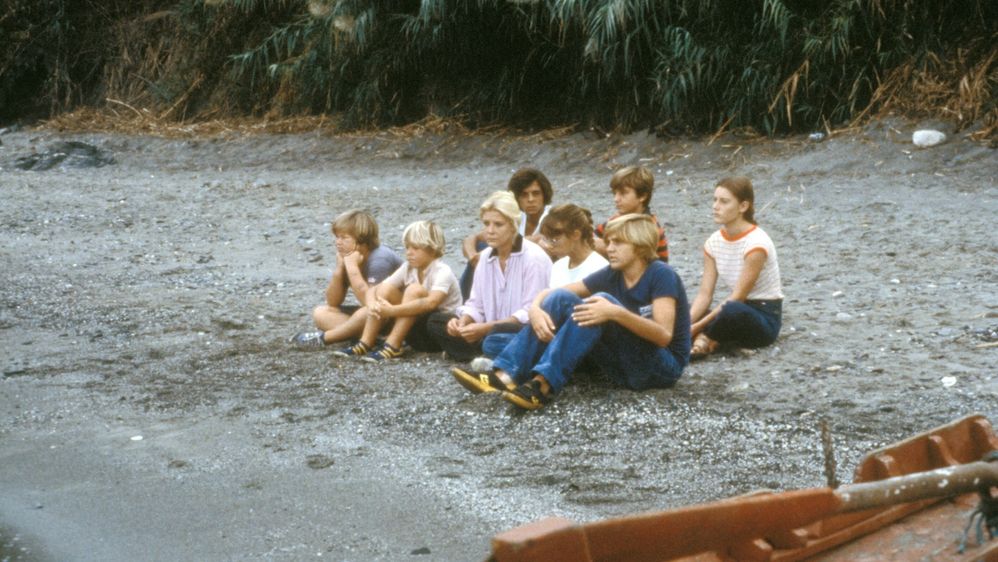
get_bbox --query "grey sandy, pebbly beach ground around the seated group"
[0,120,998,560]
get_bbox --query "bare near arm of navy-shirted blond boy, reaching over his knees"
[572,296,676,347]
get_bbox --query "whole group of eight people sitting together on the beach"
[292,166,783,410]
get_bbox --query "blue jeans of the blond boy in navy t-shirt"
[493,289,686,392]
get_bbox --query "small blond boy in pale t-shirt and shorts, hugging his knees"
[335,221,461,362]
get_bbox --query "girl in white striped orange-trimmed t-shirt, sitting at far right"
[690,176,783,359]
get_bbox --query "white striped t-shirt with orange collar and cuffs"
[703,225,783,300]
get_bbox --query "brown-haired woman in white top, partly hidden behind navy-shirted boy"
[540,204,609,289]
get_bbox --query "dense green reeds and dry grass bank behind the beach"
[0,0,998,133]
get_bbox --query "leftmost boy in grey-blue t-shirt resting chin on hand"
[291,209,402,347]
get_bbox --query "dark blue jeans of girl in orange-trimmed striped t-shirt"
[704,300,783,348]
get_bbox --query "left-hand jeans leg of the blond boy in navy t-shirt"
[493,289,585,390]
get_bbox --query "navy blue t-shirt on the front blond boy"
[582,260,690,357]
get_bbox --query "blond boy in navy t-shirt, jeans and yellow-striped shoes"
[451,214,690,410]
